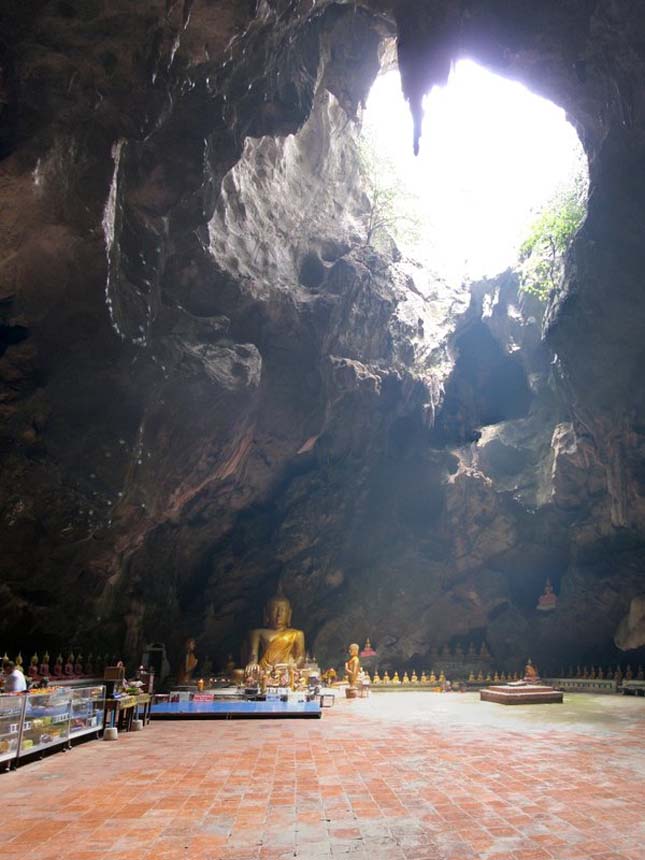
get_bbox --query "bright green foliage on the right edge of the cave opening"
[520,158,588,302]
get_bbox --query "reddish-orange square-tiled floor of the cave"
[0,693,645,860]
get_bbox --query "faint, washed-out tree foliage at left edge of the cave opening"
[358,127,422,252]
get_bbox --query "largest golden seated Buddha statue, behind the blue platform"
[246,594,305,673]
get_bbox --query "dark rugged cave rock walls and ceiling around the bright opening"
[0,0,645,856]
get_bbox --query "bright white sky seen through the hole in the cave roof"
[363,60,586,280]
